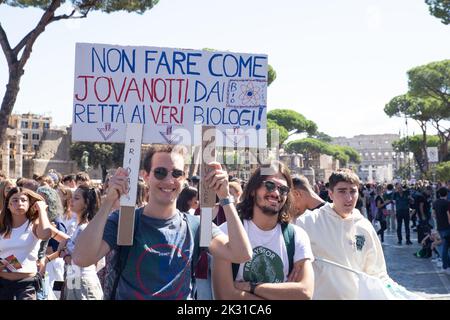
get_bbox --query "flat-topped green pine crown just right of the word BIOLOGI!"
[267,109,317,135]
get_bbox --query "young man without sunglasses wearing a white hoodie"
[297,169,389,300]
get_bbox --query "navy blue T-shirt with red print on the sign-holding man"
[103,208,221,300]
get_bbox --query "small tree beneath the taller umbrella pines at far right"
[392,134,439,176]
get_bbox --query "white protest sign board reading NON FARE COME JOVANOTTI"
[73,43,267,147]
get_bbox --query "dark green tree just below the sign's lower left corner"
[70,142,125,181]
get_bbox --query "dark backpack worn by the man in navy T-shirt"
[103,210,200,300]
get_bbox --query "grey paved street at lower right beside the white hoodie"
[383,231,450,300]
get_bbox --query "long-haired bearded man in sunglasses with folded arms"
[212,161,314,300]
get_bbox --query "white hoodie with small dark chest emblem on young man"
[296,203,388,300]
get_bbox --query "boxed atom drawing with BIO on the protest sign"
[227,80,266,108]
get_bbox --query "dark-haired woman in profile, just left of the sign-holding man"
[62,185,103,300]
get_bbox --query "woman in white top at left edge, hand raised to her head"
[0,187,63,300]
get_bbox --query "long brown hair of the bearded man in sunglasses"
[237,161,292,223]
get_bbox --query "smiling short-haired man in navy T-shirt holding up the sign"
[73,145,252,300]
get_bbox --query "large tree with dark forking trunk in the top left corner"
[0,0,159,141]
